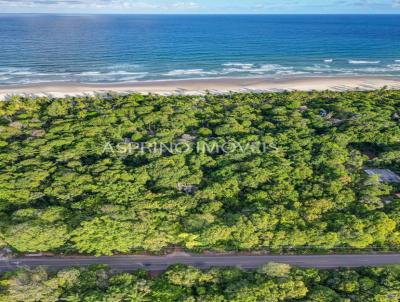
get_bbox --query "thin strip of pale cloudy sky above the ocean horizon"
[0,0,400,14]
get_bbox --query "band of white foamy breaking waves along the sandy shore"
[0,59,400,85]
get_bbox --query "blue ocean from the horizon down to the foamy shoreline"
[0,14,400,85]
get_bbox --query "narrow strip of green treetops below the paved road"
[0,263,400,302]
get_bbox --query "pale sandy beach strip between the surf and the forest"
[0,76,400,100]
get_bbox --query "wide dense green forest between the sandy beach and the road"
[0,90,400,255]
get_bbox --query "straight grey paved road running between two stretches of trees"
[0,254,400,272]
